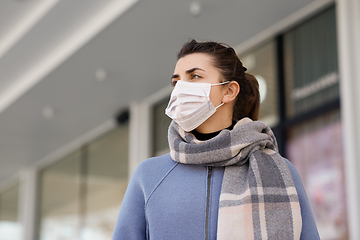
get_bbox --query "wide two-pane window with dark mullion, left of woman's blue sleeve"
[39,122,129,240]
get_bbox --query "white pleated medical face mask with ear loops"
[165,80,230,132]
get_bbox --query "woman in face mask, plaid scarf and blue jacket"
[113,40,320,240]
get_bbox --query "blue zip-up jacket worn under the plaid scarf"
[112,154,320,240]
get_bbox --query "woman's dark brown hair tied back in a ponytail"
[177,40,260,121]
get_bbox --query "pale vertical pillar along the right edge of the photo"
[336,0,360,240]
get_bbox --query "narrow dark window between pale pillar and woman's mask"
[153,96,171,156]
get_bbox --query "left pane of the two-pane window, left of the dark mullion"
[40,151,82,240]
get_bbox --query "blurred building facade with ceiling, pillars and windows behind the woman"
[0,0,360,240]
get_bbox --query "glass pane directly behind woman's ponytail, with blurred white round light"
[240,41,279,126]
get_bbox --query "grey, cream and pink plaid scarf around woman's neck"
[168,118,302,240]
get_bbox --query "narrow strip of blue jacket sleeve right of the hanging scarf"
[286,160,320,240]
